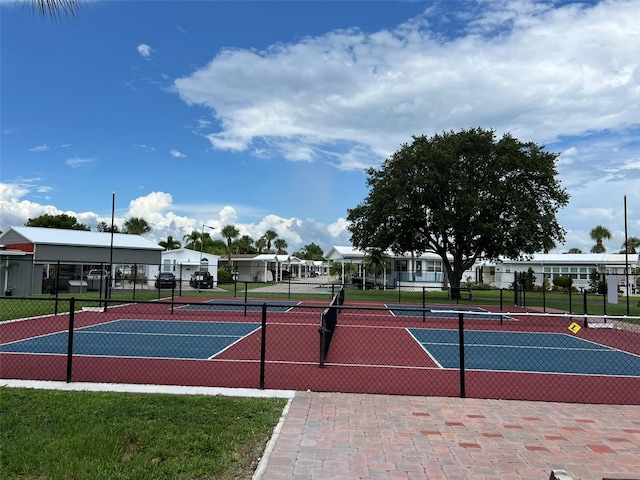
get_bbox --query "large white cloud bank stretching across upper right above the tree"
[175,1,640,172]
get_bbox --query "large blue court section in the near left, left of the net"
[0,320,260,360]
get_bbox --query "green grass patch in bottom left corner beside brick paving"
[0,388,286,480]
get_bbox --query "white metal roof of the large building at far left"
[0,227,164,250]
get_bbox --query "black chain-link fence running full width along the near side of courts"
[0,289,640,405]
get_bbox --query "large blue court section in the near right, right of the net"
[407,328,640,377]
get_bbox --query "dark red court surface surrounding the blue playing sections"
[0,300,640,405]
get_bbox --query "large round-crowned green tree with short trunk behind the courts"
[347,128,569,287]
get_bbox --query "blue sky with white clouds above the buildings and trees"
[0,0,640,253]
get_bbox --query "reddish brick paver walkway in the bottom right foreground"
[256,392,640,480]
